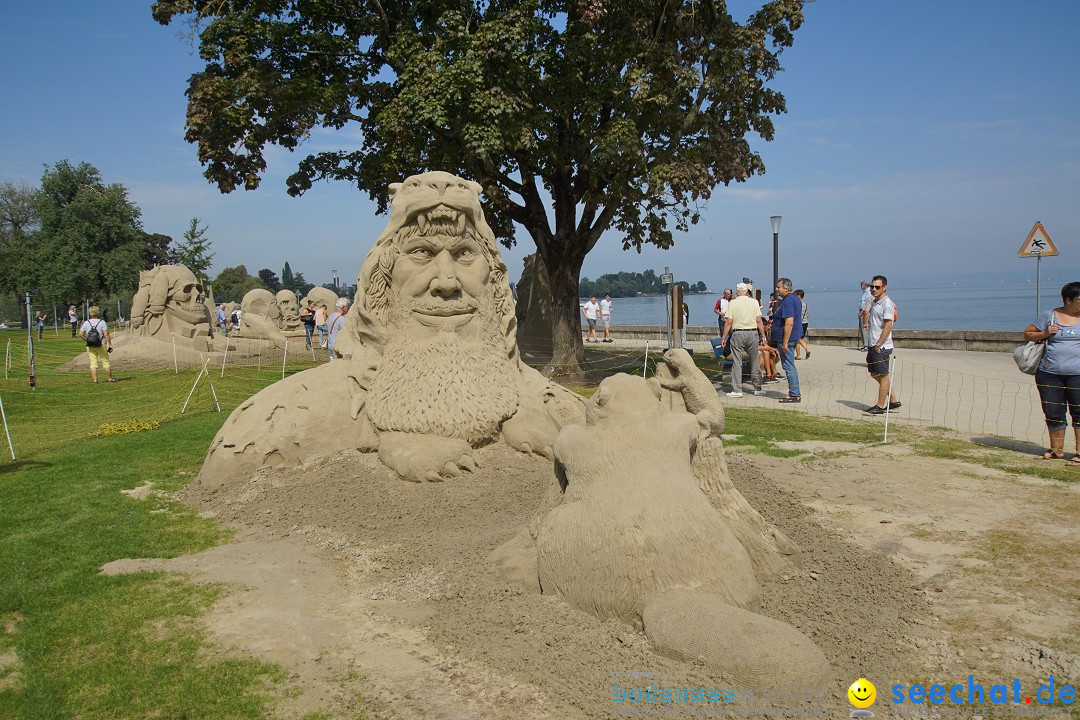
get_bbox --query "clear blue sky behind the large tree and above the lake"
[0,0,1080,288]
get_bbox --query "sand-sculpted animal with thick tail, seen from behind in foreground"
[514,358,832,689]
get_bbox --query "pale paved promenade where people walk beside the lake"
[616,340,1045,449]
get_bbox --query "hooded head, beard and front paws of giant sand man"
[336,172,581,479]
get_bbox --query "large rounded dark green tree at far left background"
[24,160,146,303]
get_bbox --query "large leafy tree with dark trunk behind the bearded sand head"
[153,0,802,369]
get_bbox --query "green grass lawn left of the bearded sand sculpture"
[0,331,332,720]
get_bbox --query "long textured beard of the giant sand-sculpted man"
[365,297,517,446]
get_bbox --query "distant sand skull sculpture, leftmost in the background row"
[131,266,213,350]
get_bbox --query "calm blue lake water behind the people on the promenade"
[596,283,1062,331]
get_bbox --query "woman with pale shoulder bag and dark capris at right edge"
[1024,283,1080,465]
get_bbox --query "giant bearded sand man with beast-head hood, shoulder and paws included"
[201,172,584,484]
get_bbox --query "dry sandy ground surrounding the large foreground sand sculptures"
[105,444,1080,718]
